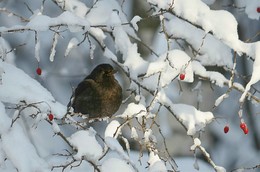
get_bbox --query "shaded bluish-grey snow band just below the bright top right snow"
[165,16,233,68]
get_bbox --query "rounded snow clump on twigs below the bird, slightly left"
[67,128,103,162]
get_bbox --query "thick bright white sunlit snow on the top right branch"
[173,0,243,51]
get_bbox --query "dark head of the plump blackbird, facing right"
[90,64,116,83]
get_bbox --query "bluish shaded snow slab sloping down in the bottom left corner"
[0,102,50,172]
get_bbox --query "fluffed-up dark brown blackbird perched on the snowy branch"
[68,64,122,119]
